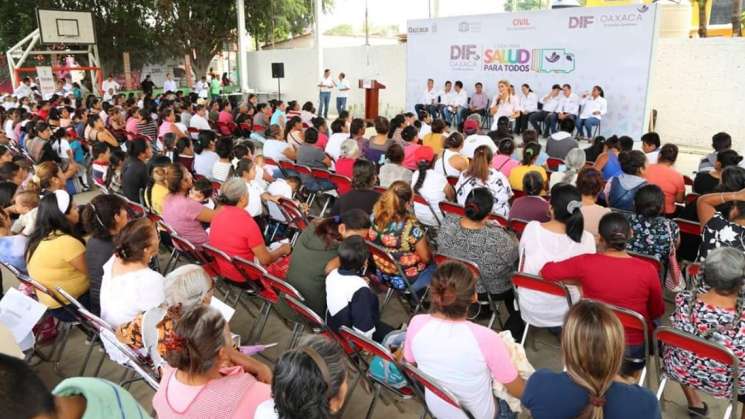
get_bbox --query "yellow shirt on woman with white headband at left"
[28,235,89,308]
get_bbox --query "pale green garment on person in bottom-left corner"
[52,377,151,419]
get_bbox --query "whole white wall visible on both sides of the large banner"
[248,38,745,152]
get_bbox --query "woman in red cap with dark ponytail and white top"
[411,147,455,227]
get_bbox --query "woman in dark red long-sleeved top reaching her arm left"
[541,212,665,375]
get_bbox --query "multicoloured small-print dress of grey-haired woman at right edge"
[663,291,745,398]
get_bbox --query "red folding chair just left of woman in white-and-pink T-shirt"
[338,326,415,418]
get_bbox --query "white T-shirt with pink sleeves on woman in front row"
[404,314,517,419]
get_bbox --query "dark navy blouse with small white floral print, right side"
[627,214,680,264]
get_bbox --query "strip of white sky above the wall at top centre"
[321,0,504,32]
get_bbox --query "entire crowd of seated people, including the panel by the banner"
[0,75,745,419]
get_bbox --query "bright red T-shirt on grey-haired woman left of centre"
[209,205,264,282]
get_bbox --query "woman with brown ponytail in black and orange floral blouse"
[369,181,435,291]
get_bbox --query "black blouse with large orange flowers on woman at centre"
[369,217,426,288]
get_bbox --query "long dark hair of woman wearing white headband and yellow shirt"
[26,193,85,261]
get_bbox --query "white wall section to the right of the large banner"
[644,38,745,152]
